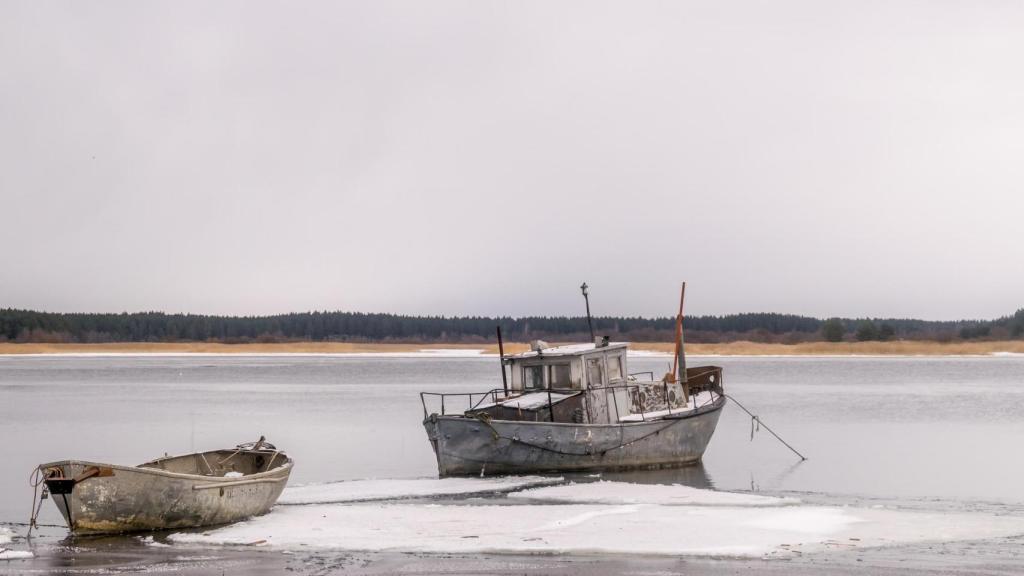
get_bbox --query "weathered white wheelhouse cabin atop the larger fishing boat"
[505,340,629,393]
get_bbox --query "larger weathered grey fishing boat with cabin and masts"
[420,283,726,477]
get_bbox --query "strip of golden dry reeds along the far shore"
[0,340,1024,357]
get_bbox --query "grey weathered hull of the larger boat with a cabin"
[423,397,725,477]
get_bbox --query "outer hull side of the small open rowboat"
[40,453,292,534]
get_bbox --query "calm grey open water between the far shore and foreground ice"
[0,357,1024,523]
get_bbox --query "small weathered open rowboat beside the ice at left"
[39,438,292,534]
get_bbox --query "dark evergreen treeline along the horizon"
[0,308,1024,343]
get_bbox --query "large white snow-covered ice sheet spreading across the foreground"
[169,483,1024,558]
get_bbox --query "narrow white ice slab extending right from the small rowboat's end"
[278,476,563,504]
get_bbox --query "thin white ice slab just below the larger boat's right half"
[509,481,800,506]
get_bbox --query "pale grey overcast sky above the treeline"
[0,0,1024,319]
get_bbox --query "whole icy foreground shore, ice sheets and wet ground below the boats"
[0,477,1024,576]
